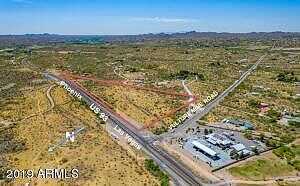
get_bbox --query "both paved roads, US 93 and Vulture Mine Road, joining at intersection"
[44,45,267,185]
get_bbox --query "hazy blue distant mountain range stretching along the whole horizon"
[0,31,300,47]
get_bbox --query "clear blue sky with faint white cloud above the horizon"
[0,0,300,34]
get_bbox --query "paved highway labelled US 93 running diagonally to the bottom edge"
[44,73,204,186]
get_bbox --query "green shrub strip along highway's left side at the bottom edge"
[145,159,170,186]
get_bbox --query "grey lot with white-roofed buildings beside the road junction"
[182,126,266,168]
